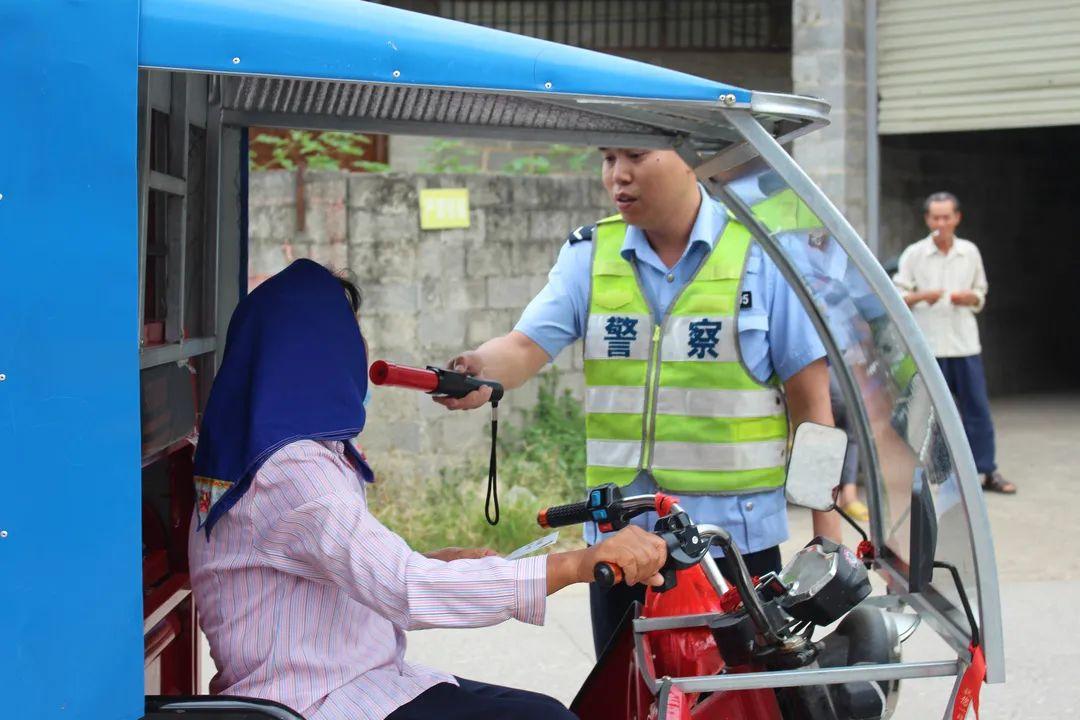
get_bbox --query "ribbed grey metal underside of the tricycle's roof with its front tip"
[208,73,829,157]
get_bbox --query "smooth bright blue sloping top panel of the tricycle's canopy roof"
[139,0,751,104]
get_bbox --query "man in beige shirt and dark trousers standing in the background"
[893,192,1016,494]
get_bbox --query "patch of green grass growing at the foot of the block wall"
[368,372,585,553]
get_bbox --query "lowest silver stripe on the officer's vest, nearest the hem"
[585,440,787,471]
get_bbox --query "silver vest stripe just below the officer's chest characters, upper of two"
[585,385,784,418]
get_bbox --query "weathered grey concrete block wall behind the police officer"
[248,171,611,467]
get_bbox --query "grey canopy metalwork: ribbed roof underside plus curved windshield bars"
[164,60,1003,682]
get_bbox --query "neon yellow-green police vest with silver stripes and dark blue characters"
[585,216,787,494]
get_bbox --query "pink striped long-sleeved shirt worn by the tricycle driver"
[189,440,546,720]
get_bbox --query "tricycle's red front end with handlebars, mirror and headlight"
[539,423,926,720]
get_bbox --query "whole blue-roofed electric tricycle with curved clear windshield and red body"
[0,0,1004,720]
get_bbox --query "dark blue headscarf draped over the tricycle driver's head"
[194,260,373,539]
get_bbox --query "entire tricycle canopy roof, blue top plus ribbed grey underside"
[139,0,828,154]
